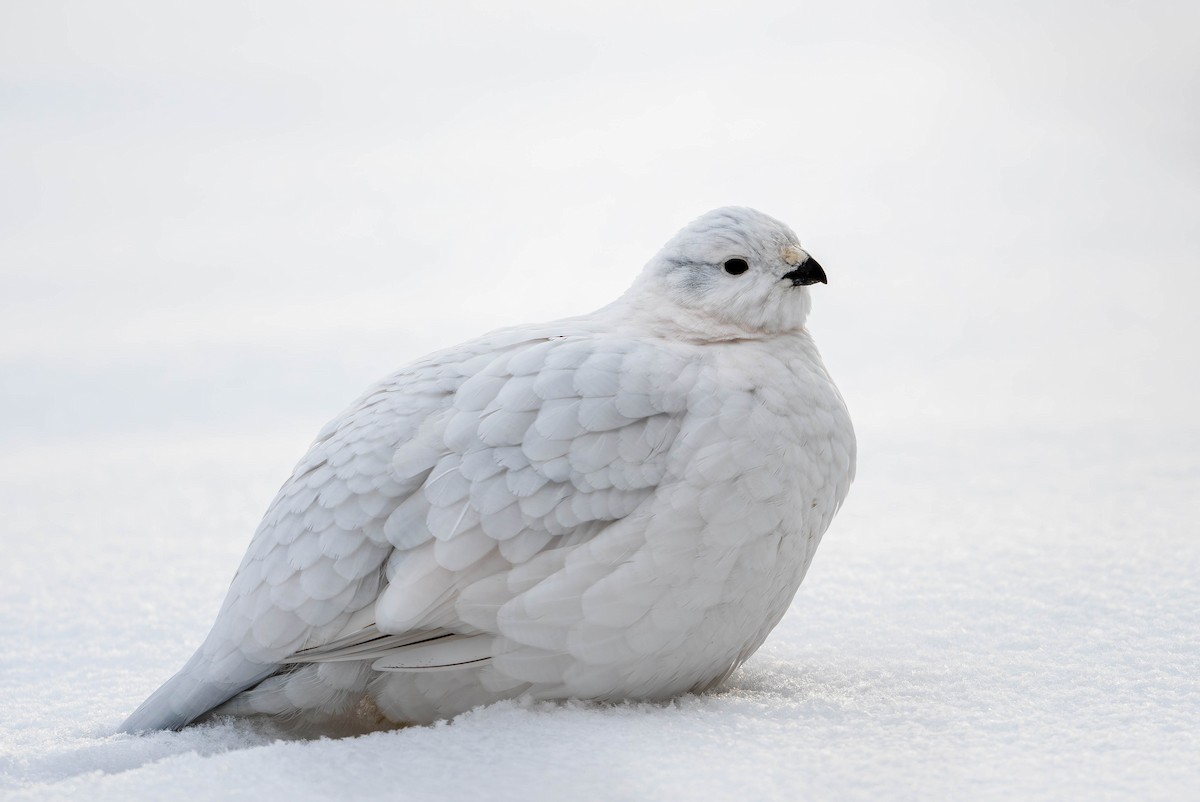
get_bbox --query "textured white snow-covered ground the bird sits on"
[0,427,1200,800]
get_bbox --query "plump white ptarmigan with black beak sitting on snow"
[121,208,856,732]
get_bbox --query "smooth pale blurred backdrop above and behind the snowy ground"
[0,1,1200,444]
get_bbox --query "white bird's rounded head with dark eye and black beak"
[630,207,826,340]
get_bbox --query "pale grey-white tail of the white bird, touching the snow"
[118,647,280,732]
